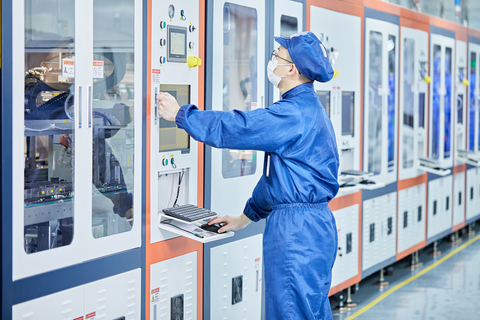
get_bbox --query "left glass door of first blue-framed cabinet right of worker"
[367,31,385,175]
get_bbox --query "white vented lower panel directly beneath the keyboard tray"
[147,251,197,320]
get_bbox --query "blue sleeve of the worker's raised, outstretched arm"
[175,102,301,152]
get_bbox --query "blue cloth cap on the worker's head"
[275,31,333,82]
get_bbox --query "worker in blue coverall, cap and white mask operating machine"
[157,32,339,320]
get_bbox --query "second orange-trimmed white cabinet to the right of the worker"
[397,22,430,259]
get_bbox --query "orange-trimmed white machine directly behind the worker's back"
[309,1,363,294]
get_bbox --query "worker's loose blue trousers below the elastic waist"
[263,203,337,320]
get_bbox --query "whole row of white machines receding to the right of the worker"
[307,0,480,300]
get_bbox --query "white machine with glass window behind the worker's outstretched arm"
[203,0,268,319]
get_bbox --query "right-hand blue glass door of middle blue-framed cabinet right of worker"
[443,47,454,159]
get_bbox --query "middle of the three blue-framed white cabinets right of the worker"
[427,26,455,244]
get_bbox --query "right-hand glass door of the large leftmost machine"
[88,0,136,238]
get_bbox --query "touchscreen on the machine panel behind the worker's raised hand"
[158,84,190,152]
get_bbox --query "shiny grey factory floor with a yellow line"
[332,227,480,320]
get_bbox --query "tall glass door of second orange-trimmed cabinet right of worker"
[401,38,416,169]
